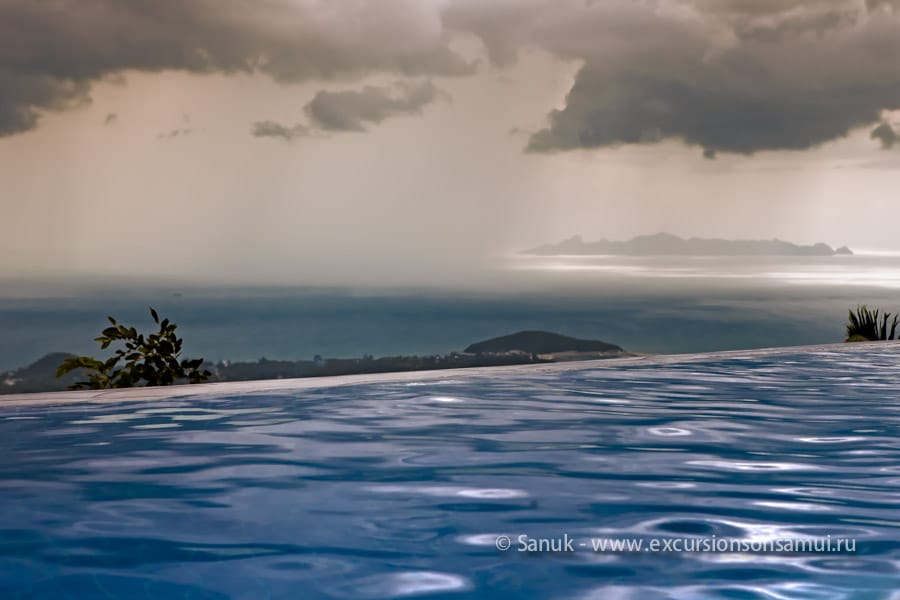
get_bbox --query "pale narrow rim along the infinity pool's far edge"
[0,341,900,410]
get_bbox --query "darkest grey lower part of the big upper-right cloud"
[528,62,900,154]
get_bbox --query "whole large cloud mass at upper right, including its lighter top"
[512,2,900,156]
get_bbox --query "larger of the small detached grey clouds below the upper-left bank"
[306,81,439,131]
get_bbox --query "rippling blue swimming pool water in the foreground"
[0,345,900,600]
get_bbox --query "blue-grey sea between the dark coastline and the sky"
[0,255,900,370]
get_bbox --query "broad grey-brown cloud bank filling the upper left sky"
[0,0,473,135]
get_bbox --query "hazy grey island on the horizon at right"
[524,233,853,256]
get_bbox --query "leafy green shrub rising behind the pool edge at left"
[56,307,211,390]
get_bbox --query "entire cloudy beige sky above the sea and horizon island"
[0,0,900,284]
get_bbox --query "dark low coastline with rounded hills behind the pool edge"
[0,331,634,394]
